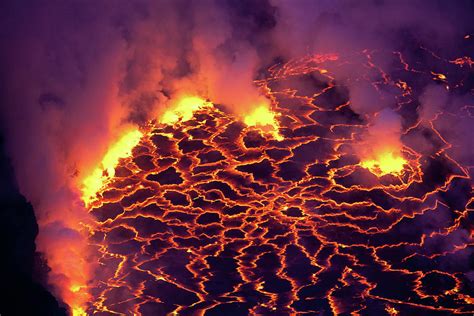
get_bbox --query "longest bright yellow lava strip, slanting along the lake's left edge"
[82,130,142,204]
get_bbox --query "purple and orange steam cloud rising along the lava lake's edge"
[0,0,474,312]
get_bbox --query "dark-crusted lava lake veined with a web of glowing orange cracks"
[70,52,474,315]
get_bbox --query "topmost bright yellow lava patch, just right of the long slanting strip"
[160,97,212,124]
